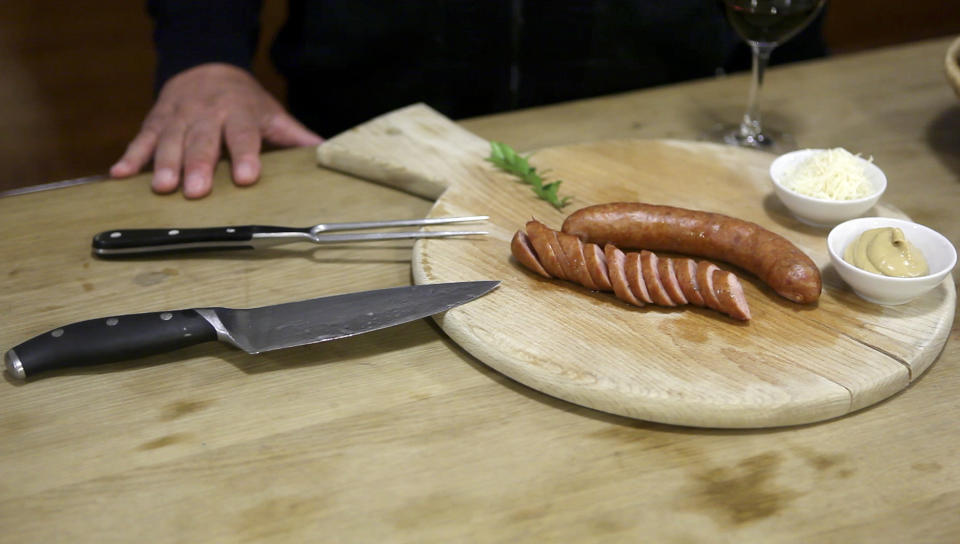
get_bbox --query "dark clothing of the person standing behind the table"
[148,0,826,136]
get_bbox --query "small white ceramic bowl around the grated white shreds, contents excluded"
[770,149,887,227]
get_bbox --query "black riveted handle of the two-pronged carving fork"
[93,226,258,257]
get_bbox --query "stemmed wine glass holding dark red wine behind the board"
[721,0,825,150]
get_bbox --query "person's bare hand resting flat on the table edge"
[110,64,323,198]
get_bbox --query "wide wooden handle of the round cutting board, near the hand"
[317,104,490,200]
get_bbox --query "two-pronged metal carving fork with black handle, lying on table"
[92,215,489,257]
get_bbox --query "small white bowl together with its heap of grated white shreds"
[770,147,887,227]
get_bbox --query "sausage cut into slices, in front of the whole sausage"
[510,221,750,321]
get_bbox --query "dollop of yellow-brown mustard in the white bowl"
[843,227,928,278]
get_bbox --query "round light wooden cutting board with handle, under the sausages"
[318,105,956,428]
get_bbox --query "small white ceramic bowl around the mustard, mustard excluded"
[827,217,957,305]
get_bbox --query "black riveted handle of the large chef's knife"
[4,310,217,379]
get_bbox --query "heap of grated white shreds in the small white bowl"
[783,147,873,200]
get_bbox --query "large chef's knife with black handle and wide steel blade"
[4,281,500,379]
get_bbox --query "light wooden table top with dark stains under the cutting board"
[0,40,960,543]
